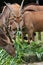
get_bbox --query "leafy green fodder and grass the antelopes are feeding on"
[0,31,43,65]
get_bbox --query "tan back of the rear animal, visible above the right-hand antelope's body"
[23,4,43,12]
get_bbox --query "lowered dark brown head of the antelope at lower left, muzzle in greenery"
[0,28,15,56]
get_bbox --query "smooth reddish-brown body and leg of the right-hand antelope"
[23,11,43,42]
